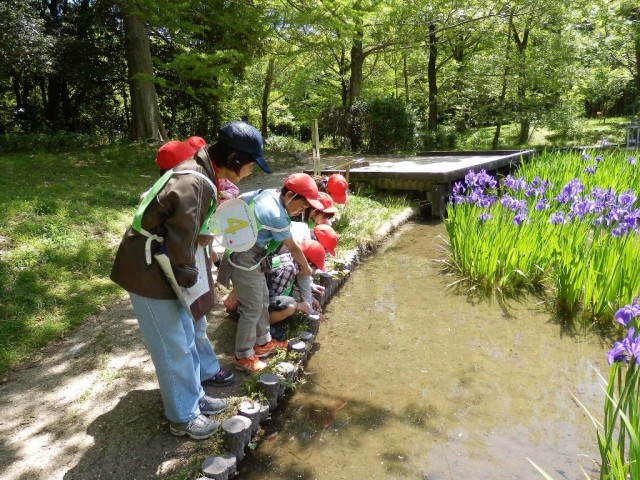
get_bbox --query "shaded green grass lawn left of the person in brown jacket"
[0,145,157,373]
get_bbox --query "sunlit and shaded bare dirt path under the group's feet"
[0,163,301,480]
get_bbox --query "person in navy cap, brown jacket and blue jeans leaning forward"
[111,122,271,439]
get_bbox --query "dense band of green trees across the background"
[0,0,640,151]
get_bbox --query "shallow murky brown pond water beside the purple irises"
[240,224,607,480]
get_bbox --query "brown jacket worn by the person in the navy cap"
[111,147,216,299]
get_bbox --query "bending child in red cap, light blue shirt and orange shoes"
[228,173,322,373]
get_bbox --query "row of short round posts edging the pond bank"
[198,208,418,480]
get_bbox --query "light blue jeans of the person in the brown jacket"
[129,292,220,422]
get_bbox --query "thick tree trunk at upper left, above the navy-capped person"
[124,14,167,142]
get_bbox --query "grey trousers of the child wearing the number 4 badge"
[231,252,271,358]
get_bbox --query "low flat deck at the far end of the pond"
[305,150,533,217]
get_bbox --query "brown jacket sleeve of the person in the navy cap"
[159,175,213,287]
